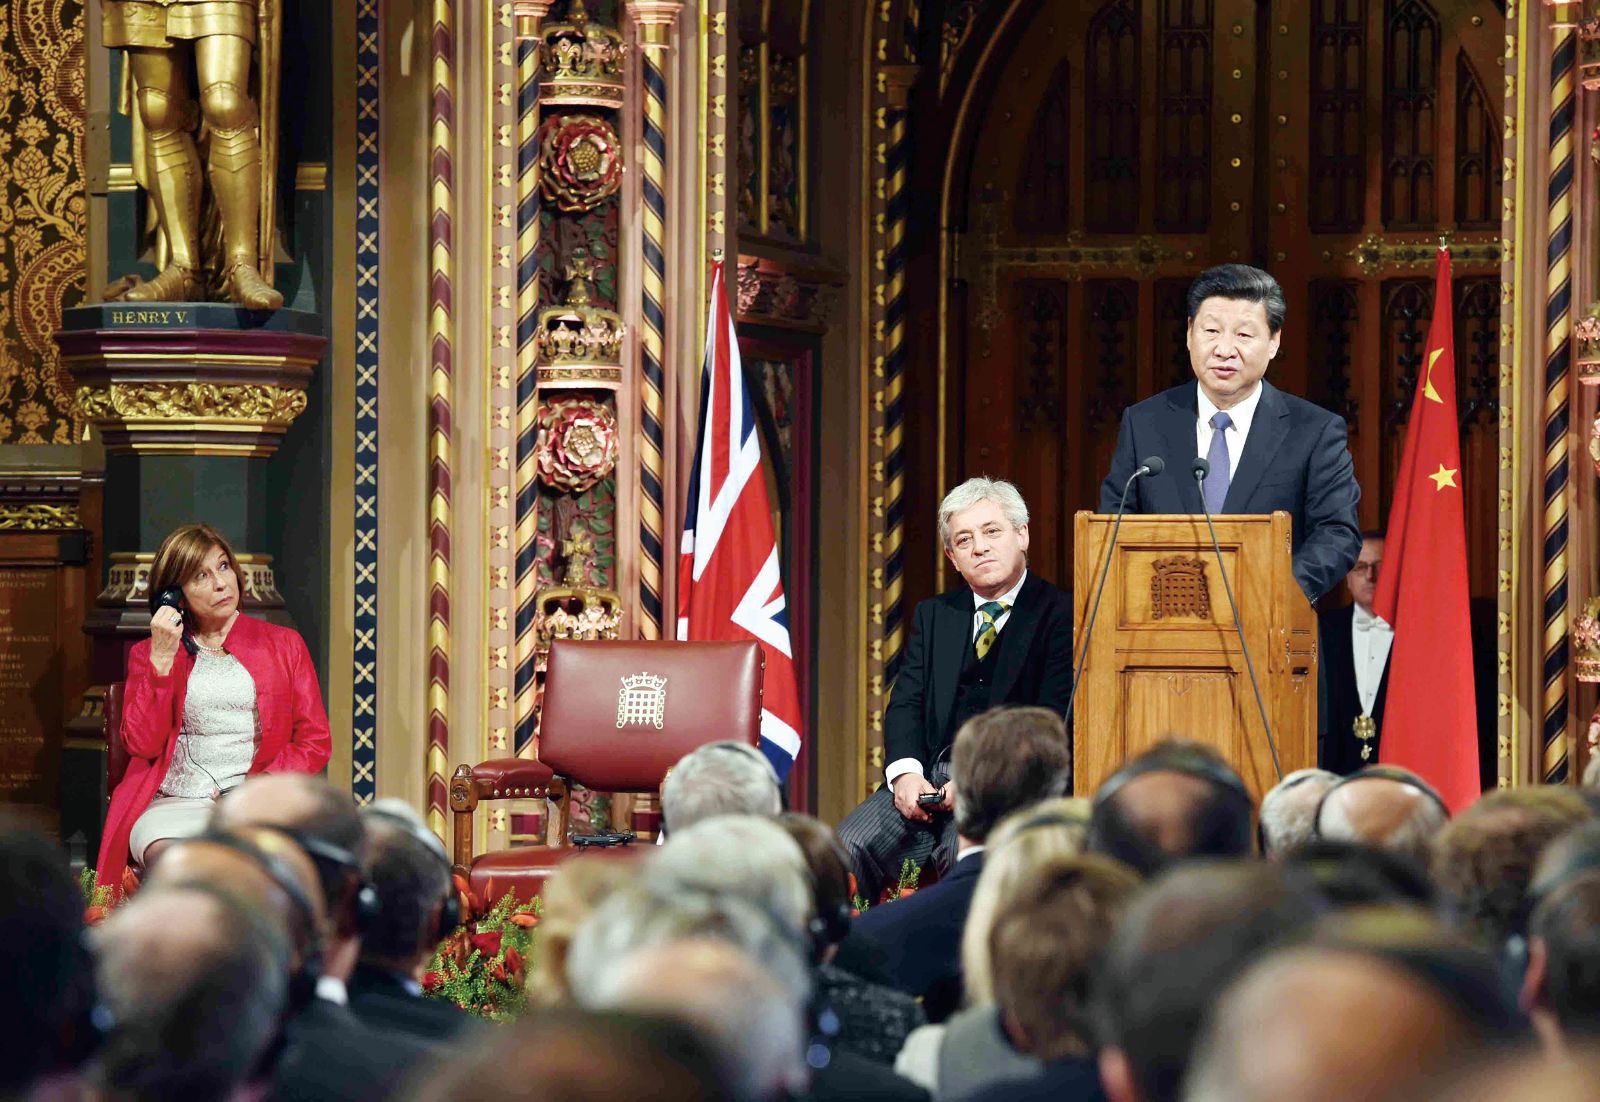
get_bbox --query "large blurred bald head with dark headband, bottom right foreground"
[1184,910,1520,1102]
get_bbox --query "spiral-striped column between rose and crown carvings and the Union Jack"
[627,0,683,640]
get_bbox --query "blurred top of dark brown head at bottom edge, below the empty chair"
[416,1008,736,1102]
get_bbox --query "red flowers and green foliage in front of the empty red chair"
[422,892,542,1022]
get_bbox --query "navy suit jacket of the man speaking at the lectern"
[1101,379,1362,601]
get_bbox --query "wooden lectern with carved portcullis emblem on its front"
[1072,512,1317,805]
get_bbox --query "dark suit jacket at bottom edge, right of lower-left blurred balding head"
[267,996,443,1102]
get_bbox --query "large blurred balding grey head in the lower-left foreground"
[93,883,290,1102]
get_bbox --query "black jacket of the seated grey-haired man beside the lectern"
[883,571,1072,769]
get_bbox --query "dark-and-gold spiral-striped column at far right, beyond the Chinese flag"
[1539,27,1578,782]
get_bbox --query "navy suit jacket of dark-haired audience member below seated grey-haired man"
[851,844,985,1022]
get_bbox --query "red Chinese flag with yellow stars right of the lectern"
[1373,248,1482,811]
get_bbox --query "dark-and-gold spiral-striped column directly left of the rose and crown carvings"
[512,0,550,753]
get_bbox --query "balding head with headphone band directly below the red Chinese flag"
[1315,765,1450,865]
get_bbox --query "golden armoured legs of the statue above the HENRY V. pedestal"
[102,0,283,310]
